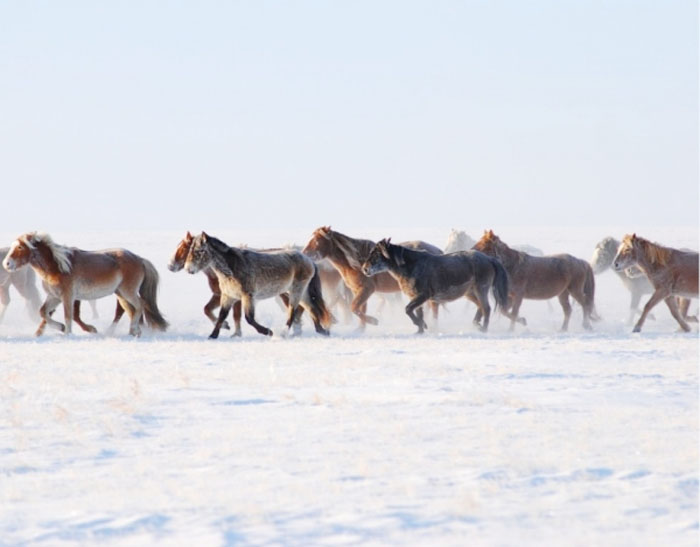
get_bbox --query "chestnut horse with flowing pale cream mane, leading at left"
[2,232,168,336]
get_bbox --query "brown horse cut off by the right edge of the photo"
[613,234,698,332]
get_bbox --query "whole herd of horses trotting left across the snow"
[0,226,698,338]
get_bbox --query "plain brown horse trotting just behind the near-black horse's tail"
[474,230,597,331]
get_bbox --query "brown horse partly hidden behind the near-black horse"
[302,226,442,330]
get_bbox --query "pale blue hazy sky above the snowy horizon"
[0,0,698,233]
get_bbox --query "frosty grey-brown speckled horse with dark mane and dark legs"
[185,232,332,339]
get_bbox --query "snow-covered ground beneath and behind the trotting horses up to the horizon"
[0,226,699,545]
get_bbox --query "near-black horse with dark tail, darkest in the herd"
[362,239,508,334]
